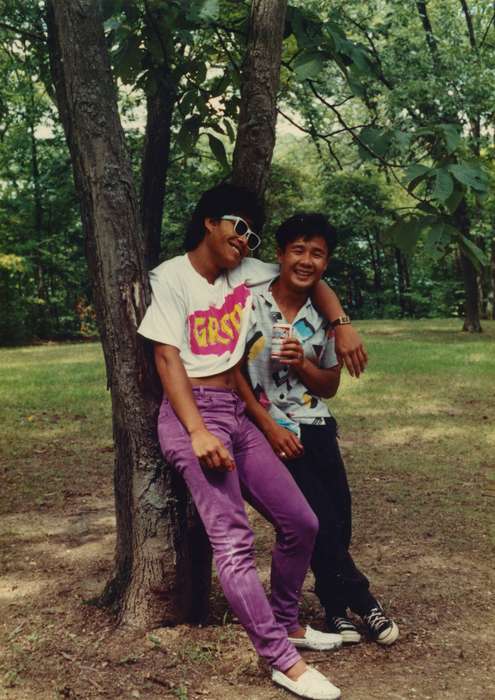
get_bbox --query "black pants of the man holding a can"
[286,418,376,617]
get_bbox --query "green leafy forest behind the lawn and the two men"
[0,0,495,344]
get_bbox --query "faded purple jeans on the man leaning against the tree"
[158,387,318,671]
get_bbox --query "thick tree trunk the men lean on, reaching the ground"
[47,0,213,627]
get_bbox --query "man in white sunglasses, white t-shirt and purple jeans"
[139,184,365,700]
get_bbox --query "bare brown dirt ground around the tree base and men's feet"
[0,486,495,700]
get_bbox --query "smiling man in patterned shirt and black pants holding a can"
[234,214,399,645]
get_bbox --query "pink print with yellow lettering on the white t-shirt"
[187,284,251,355]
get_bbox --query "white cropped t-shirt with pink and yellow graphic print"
[138,253,278,377]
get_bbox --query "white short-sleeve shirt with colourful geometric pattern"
[246,280,338,435]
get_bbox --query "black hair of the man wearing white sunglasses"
[184,182,265,251]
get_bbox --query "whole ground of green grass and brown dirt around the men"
[0,319,495,700]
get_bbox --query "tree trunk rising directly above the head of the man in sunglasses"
[232,0,287,196]
